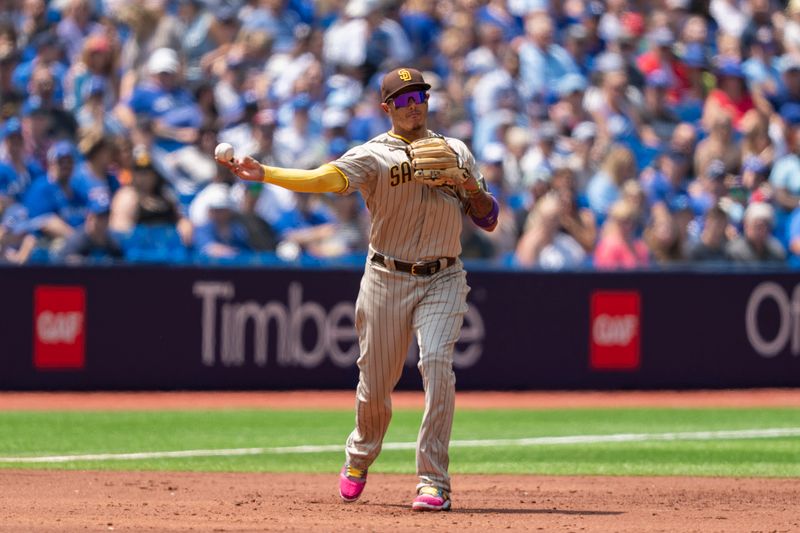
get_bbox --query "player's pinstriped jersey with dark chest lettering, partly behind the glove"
[331,133,483,261]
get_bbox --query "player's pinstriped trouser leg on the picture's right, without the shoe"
[414,268,469,507]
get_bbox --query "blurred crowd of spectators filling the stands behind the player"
[0,0,800,269]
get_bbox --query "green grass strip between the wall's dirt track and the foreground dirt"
[0,408,800,477]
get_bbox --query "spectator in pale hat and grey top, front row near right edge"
[726,202,786,264]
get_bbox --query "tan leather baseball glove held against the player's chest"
[406,137,469,187]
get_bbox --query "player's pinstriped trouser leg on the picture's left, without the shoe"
[346,264,417,469]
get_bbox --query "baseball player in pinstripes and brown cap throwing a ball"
[217,68,498,511]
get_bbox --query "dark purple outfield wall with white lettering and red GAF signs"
[0,267,800,390]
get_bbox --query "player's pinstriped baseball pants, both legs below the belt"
[346,260,469,492]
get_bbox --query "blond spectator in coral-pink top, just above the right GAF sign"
[594,199,650,270]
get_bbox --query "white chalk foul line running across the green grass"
[0,428,800,463]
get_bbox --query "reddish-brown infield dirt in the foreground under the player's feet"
[0,471,800,532]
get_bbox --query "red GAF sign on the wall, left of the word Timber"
[33,286,86,369]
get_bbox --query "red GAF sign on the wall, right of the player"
[589,291,641,370]
